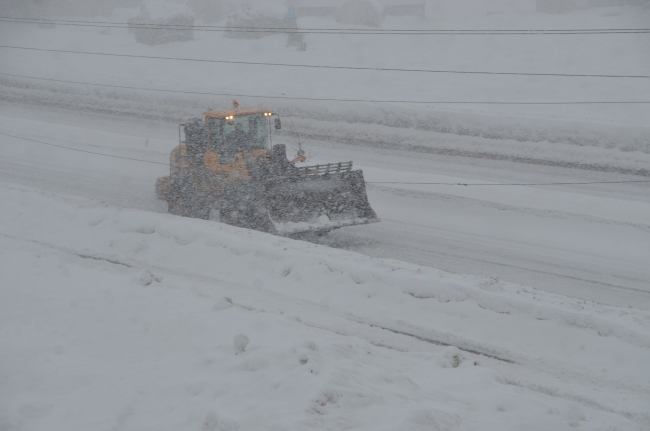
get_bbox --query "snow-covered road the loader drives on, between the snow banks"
[0,108,650,310]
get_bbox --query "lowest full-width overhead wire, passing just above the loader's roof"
[0,72,650,105]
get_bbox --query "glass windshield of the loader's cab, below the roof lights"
[208,114,269,152]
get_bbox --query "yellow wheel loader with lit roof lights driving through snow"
[156,109,379,236]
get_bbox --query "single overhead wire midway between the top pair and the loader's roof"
[0,45,650,79]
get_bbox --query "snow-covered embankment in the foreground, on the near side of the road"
[0,186,650,431]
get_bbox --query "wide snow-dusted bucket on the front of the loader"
[265,162,379,235]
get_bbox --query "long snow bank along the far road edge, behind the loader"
[0,77,650,176]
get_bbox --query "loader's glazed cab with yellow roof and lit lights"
[204,109,274,155]
